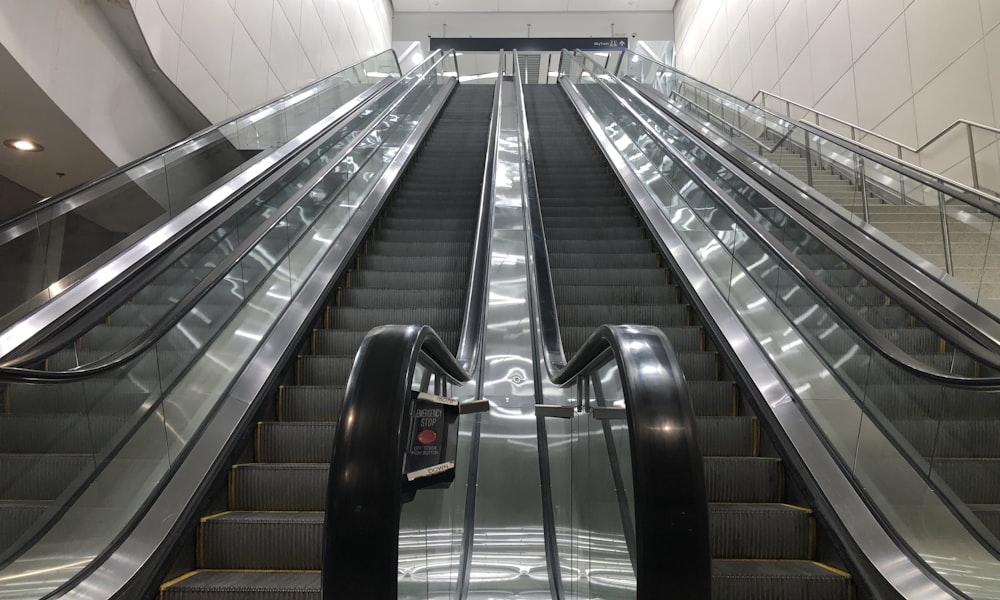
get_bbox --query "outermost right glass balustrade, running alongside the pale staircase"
[622,54,1000,314]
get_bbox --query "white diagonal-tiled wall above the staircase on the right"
[675,0,1000,190]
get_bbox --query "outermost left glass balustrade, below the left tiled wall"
[0,52,400,324]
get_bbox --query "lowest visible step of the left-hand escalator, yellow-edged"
[160,569,322,600]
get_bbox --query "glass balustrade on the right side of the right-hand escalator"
[564,51,1000,598]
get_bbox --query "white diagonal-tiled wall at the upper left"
[130,0,392,122]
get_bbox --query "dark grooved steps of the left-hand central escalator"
[161,86,493,599]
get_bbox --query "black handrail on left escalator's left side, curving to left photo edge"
[0,50,458,383]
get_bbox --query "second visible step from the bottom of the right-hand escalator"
[708,503,815,560]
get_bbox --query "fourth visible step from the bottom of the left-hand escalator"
[257,421,337,464]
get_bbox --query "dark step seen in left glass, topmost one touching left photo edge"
[0,414,125,454]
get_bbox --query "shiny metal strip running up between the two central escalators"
[467,82,551,598]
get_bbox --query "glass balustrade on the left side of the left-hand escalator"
[0,48,450,597]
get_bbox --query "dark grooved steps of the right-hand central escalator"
[525,86,852,598]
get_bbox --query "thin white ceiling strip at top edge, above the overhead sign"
[392,0,676,13]
